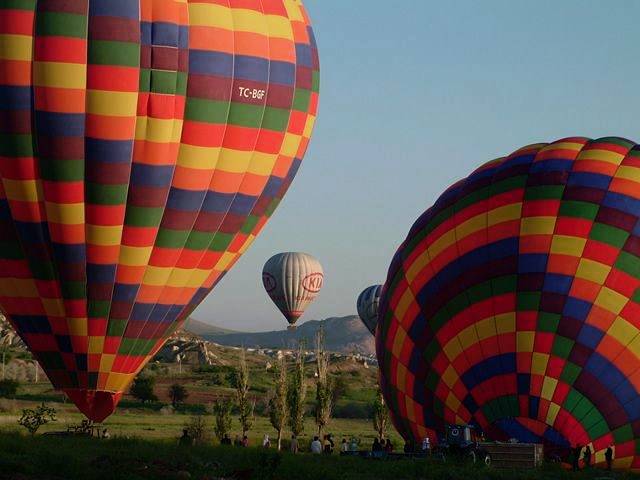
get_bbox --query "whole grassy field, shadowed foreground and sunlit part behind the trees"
[0,350,640,480]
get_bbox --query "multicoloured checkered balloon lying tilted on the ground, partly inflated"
[376,138,640,469]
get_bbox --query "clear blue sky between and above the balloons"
[194,0,640,331]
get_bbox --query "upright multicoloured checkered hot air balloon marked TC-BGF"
[0,0,319,421]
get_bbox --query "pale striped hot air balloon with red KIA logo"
[262,252,324,330]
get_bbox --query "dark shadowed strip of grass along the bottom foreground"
[0,433,638,480]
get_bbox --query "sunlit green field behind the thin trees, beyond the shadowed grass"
[0,348,401,447]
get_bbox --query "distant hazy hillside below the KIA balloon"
[200,316,375,355]
